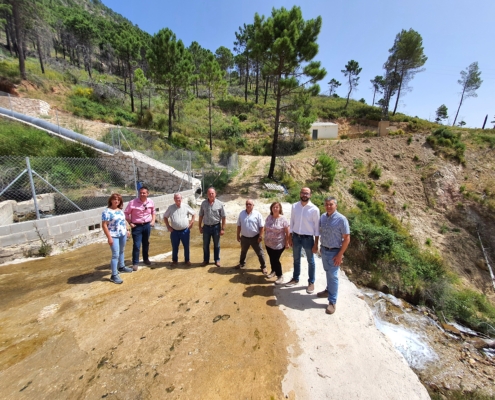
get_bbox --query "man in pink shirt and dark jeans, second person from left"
[124,186,156,271]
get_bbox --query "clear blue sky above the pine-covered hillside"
[103,0,495,127]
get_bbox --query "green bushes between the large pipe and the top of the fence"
[0,119,96,158]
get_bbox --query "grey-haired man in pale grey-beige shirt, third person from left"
[163,193,196,265]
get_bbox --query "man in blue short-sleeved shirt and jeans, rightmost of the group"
[317,197,351,314]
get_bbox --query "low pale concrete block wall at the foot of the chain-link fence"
[0,190,195,264]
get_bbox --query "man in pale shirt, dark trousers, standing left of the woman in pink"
[236,199,268,275]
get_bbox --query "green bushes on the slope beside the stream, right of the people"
[347,180,495,333]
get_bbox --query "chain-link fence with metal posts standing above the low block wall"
[0,157,141,222]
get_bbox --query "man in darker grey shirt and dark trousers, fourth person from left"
[199,187,226,267]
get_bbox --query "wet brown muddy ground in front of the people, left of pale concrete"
[0,225,297,399]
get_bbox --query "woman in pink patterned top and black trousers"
[265,201,289,285]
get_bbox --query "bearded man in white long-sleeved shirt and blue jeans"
[285,187,320,294]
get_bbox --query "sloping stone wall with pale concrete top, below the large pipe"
[102,151,201,193]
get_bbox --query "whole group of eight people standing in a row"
[102,187,350,314]
